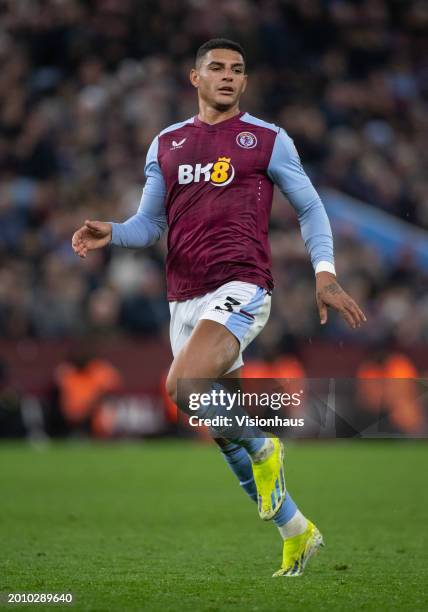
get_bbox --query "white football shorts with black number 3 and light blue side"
[169,281,271,372]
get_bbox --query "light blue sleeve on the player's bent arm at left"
[111,137,167,249]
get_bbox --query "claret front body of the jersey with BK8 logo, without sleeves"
[158,116,276,300]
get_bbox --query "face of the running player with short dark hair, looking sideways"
[190,49,247,110]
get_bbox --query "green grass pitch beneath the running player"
[0,441,428,612]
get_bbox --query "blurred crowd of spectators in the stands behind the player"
[0,0,428,352]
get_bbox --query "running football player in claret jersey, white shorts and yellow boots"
[72,39,366,576]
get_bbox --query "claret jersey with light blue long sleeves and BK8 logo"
[112,113,334,301]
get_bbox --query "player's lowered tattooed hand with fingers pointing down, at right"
[316,272,367,329]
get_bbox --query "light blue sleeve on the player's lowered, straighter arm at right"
[267,129,334,269]
